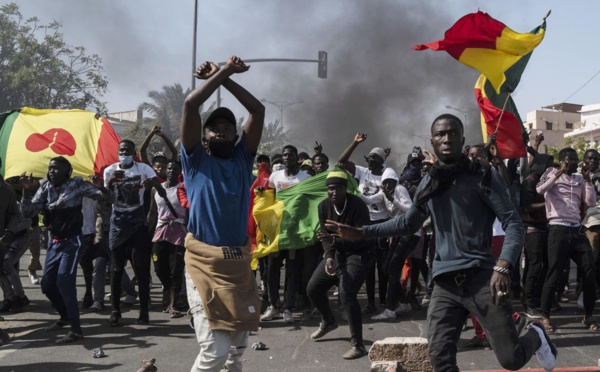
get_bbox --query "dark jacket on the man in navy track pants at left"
[21,177,112,239]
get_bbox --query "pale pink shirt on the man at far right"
[536,168,596,224]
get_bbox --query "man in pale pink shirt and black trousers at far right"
[536,147,600,332]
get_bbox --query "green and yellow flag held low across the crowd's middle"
[253,167,359,258]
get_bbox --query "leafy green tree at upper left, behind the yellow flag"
[0,3,108,114]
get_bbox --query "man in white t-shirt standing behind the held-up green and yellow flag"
[260,145,310,323]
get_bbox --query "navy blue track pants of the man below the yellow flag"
[41,235,82,332]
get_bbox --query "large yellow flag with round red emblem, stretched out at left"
[0,107,120,178]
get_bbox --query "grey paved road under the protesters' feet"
[0,250,600,372]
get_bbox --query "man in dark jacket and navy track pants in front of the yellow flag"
[19,156,112,344]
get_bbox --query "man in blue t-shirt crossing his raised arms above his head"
[181,56,264,371]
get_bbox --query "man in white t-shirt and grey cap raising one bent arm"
[338,133,389,314]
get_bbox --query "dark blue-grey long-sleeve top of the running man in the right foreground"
[363,169,525,277]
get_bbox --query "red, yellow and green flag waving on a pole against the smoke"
[413,12,550,159]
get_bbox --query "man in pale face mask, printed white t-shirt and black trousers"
[104,140,166,326]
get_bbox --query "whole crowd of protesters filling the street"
[0,57,600,371]
